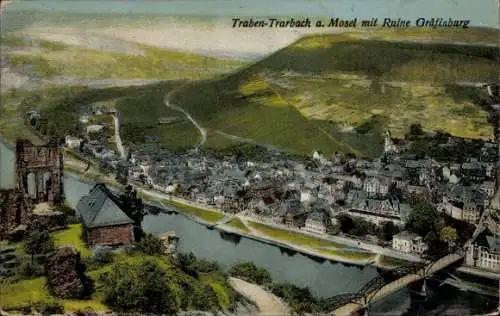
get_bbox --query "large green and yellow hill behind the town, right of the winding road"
[173,29,500,156]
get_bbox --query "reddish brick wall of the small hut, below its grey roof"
[87,224,134,248]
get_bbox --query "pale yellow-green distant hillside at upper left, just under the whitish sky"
[2,35,245,80]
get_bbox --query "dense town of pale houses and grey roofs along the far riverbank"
[45,84,500,272]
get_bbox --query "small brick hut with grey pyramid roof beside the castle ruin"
[76,183,134,248]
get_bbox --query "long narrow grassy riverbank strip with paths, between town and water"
[63,160,405,269]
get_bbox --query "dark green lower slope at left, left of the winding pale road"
[0,81,201,150]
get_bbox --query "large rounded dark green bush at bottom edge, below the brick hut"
[102,261,178,315]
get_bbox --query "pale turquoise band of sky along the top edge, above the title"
[4,0,499,28]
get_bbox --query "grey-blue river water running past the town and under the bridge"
[0,143,495,315]
